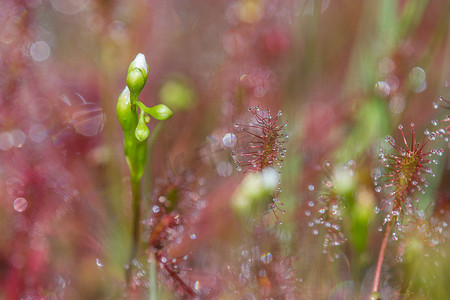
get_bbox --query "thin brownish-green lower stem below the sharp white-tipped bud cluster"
[127,178,141,285]
